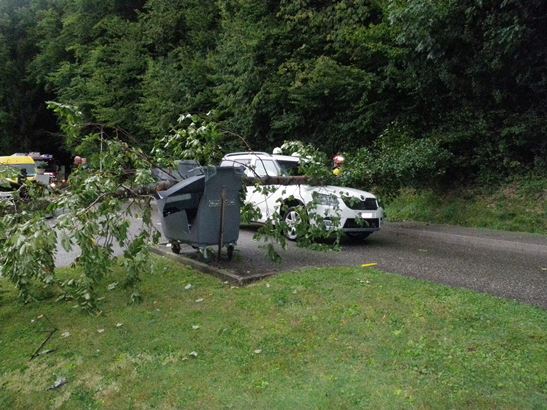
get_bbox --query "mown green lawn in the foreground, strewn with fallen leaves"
[0,259,547,409]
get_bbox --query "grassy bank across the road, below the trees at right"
[386,177,547,234]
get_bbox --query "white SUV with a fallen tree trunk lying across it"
[220,152,384,240]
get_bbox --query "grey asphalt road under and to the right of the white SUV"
[57,211,547,309]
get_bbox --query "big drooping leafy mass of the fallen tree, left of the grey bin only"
[0,103,158,312]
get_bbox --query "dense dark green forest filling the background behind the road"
[0,0,547,183]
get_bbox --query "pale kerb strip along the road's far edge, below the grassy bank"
[385,225,547,257]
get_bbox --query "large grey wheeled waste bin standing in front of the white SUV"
[157,167,243,259]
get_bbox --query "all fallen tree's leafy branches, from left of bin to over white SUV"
[0,103,346,313]
